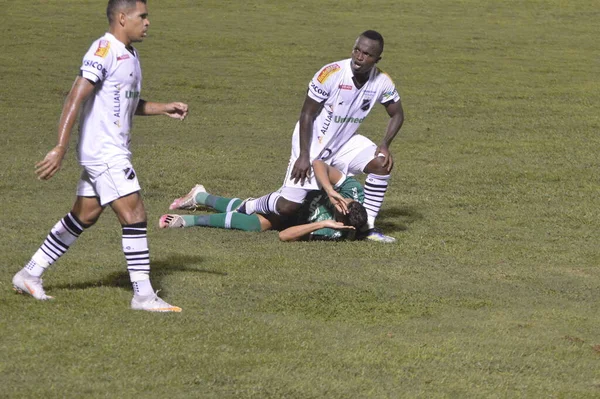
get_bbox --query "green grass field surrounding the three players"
[0,0,600,398]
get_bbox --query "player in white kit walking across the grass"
[13,0,188,312]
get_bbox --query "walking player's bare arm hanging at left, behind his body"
[35,76,94,180]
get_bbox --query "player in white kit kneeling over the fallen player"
[238,30,404,242]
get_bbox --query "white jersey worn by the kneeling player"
[308,58,400,161]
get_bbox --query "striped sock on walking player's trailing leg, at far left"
[24,212,88,277]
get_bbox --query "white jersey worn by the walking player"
[77,33,142,165]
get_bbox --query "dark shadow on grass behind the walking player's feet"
[51,254,227,290]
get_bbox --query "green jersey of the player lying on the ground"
[296,177,365,240]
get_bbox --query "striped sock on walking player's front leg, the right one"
[122,222,154,296]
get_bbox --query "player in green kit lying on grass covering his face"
[159,160,367,241]
